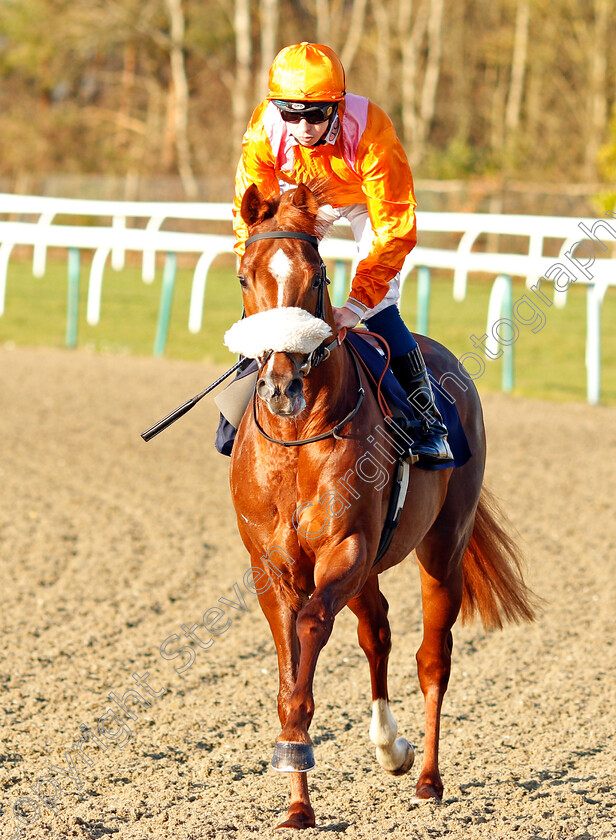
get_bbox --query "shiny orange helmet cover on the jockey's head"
[267,41,346,102]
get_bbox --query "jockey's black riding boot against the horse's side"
[391,347,453,463]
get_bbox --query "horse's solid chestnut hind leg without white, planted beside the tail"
[416,549,462,800]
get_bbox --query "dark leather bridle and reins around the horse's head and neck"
[245,230,364,446]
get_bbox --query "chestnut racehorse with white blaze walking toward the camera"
[227,184,534,828]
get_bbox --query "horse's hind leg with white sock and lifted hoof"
[349,575,415,776]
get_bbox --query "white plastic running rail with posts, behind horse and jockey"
[0,193,616,403]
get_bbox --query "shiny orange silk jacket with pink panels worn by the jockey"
[233,93,417,309]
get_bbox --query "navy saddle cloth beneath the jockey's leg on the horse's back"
[215,332,471,470]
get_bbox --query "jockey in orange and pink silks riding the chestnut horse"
[233,42,453,463]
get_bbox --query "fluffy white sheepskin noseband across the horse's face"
[225,306,332,359]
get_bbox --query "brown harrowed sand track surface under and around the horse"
[0,348,616,840]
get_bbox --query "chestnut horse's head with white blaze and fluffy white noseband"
[225,184,334,417]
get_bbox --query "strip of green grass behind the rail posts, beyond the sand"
[0,258,616,404]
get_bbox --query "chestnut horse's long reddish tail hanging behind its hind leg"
[461,487,539,629]
